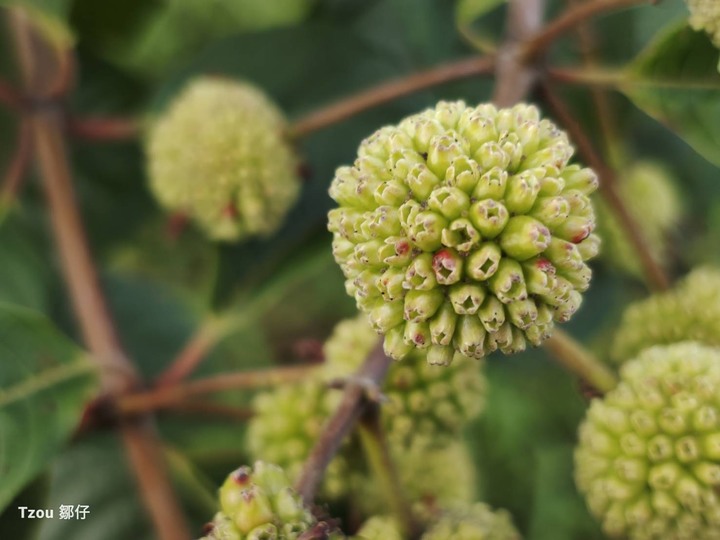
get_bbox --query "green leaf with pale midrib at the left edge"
[0,304,97,508]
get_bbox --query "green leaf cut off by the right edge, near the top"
[620,24,720,165]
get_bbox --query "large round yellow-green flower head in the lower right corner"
[575,342,720,540]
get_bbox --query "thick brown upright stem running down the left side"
[10,9,190,540]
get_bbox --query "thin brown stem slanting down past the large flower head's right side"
[543,82,670,291]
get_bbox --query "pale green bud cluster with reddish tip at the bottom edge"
[205,461,316,540]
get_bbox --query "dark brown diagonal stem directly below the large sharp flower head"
[295,339,392,504]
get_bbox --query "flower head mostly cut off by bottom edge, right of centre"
[422,503,520,540]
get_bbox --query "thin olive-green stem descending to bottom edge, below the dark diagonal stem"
[357,410,422,539]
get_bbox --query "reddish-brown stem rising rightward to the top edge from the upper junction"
[522,0,652,59]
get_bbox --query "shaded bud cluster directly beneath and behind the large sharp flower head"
[322,315,487,447]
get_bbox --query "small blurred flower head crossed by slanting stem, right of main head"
[597,161,682,277]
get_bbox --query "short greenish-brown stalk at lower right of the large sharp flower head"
[543,328,617,394]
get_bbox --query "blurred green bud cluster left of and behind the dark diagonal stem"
[246,379,360,499]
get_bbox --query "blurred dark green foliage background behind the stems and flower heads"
[0,0,720,540]
